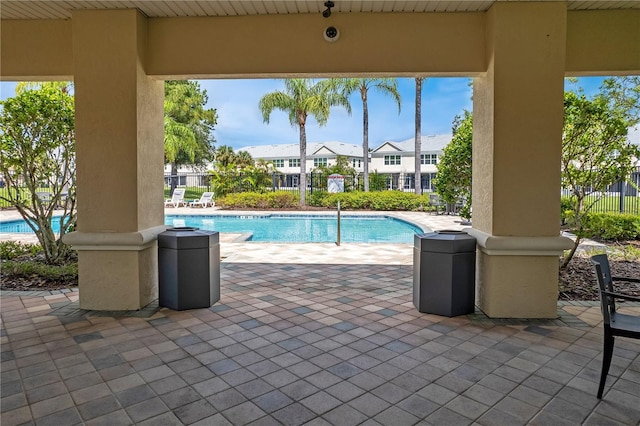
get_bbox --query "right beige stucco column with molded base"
[470,2,570,318]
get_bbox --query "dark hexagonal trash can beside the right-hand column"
[413,231,476,317]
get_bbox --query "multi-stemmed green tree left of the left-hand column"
[0,83,76,264]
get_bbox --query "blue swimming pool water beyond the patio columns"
[0,214,423,244]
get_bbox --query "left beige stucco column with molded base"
[65,10,164,310]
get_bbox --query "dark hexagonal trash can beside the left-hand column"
[158,227,220,311]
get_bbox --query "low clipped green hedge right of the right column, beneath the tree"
[580,213,640,241]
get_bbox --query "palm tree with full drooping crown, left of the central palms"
[259,78,351,206]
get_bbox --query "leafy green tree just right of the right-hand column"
[562,92,640,267]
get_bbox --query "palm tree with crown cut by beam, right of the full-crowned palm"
[340,78,400,191]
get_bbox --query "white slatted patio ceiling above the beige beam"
[0,0,640,19]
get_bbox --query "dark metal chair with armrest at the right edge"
[591,254,640,399]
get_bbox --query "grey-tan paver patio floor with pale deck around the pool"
[0,209,640,426]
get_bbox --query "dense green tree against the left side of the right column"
[434,111,473,219]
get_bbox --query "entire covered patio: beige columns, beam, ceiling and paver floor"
[0,0,640,425]
